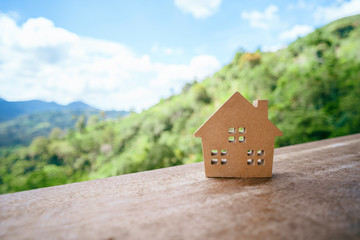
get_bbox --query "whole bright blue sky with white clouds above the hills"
[0,0,360,110]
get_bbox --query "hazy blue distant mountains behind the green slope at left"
[0,98,128,147]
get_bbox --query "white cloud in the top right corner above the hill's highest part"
[314,0,360,23]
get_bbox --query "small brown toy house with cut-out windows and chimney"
[194,92,282,177]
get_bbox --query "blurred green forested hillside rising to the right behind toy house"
[0,15,360,193]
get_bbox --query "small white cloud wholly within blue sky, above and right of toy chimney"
[241,5,279,29]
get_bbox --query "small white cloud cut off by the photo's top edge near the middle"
[174,0,222,19]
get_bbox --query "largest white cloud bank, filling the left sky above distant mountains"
[0,14,220,110]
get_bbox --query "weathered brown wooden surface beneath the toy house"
[0,134,360,239]
